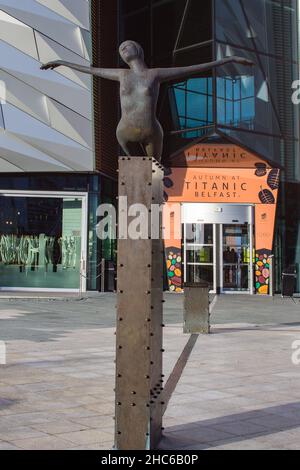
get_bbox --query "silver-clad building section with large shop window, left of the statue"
[0,0,118,291]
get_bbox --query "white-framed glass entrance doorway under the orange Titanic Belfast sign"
[182,203,254,294]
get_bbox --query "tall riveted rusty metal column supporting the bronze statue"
[115,157,163,450]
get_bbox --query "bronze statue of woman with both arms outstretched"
[41,41,253,161]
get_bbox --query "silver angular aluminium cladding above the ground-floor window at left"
[0,0,95,172]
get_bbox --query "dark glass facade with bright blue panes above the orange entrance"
[120,0,300,287]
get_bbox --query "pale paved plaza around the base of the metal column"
[0,294,300,450]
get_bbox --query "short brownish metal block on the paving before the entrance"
[183,282,210,334]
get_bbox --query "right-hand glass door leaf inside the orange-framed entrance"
[220,224,253,292]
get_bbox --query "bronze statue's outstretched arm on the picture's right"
[157,56,254,82]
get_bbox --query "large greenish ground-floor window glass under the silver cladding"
[0,196,83,289]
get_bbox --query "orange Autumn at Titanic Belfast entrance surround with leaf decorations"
[164,156,280,294]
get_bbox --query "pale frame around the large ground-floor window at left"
[0,189,88,293]
